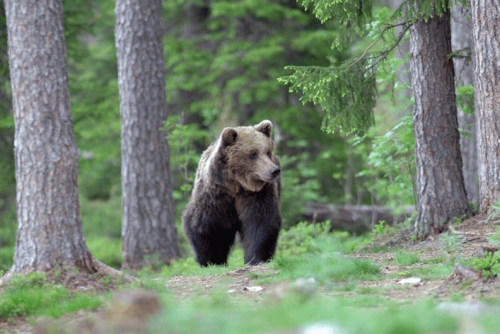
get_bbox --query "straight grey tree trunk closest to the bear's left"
[116,0,179,269]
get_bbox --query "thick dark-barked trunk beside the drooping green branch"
[410,4,467,238]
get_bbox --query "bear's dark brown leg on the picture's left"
[182,201,237,267]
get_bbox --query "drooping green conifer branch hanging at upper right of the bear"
[280,0,458,134]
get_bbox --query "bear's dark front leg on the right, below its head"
[236,183,281,265]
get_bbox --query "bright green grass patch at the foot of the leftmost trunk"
[0,273,103,321]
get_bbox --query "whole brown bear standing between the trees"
[182,120,281,266]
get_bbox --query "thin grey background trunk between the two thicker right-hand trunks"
[451,4,479,203]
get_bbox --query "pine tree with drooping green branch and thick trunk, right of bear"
[281,0,467,238]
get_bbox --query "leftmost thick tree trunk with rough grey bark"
[5,0,96,273]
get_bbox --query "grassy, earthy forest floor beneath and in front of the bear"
[0,216,500,333]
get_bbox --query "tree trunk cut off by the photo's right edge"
[471,0,500,213]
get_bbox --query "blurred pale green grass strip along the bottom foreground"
[151,294,458,334]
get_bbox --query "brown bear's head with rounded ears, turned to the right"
[220,120,280,192]
